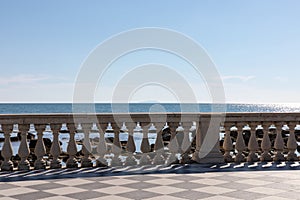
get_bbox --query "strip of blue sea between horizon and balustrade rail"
[0,103,300,114]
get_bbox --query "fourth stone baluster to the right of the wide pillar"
[260,124,272,162]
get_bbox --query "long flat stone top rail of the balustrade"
[0,113,300,124]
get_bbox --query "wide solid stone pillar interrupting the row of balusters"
[193,118,224,164]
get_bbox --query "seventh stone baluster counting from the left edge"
[96,123,108,167]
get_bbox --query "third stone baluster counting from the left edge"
[34,125,46,169]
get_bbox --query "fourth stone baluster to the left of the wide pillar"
[140,124,152,165]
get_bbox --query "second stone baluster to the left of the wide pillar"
[163,123,179,165]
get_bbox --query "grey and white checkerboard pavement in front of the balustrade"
[0,165,300,200]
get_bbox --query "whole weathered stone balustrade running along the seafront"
[0,113,300,171]
